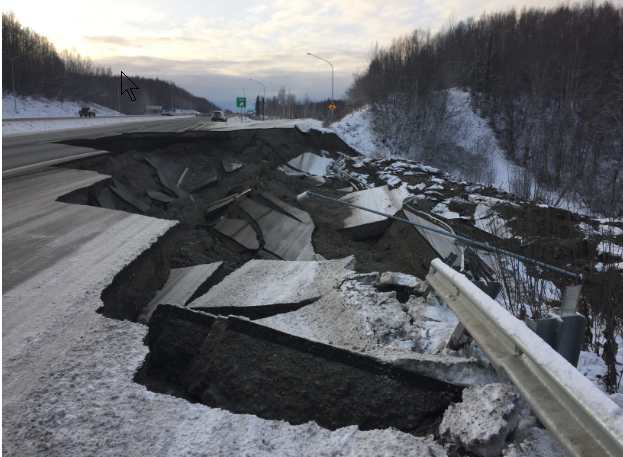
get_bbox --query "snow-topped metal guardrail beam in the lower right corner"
[426,259,623,457]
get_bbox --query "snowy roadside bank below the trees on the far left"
[2,95,123,119]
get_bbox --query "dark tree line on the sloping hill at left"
[2,13,217,114]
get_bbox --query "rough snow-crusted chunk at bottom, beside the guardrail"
[439,383,520,457]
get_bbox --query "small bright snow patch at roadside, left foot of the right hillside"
[331,106,389,157]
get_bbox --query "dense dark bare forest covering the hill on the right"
[349,2,623,215]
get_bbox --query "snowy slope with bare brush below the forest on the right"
[331,88,590,214]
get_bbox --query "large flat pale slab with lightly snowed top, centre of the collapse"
[189,257,353,316]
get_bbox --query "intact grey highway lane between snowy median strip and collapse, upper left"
[2,116,206,174]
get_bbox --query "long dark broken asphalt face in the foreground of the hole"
[143,305,461,435]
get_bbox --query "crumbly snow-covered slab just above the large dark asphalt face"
[257,273,497,385]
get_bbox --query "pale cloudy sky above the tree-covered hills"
[2,0,580,108]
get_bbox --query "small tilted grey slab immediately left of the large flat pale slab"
[138,262,223,323]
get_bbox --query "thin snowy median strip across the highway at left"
[2,116,179,136]
